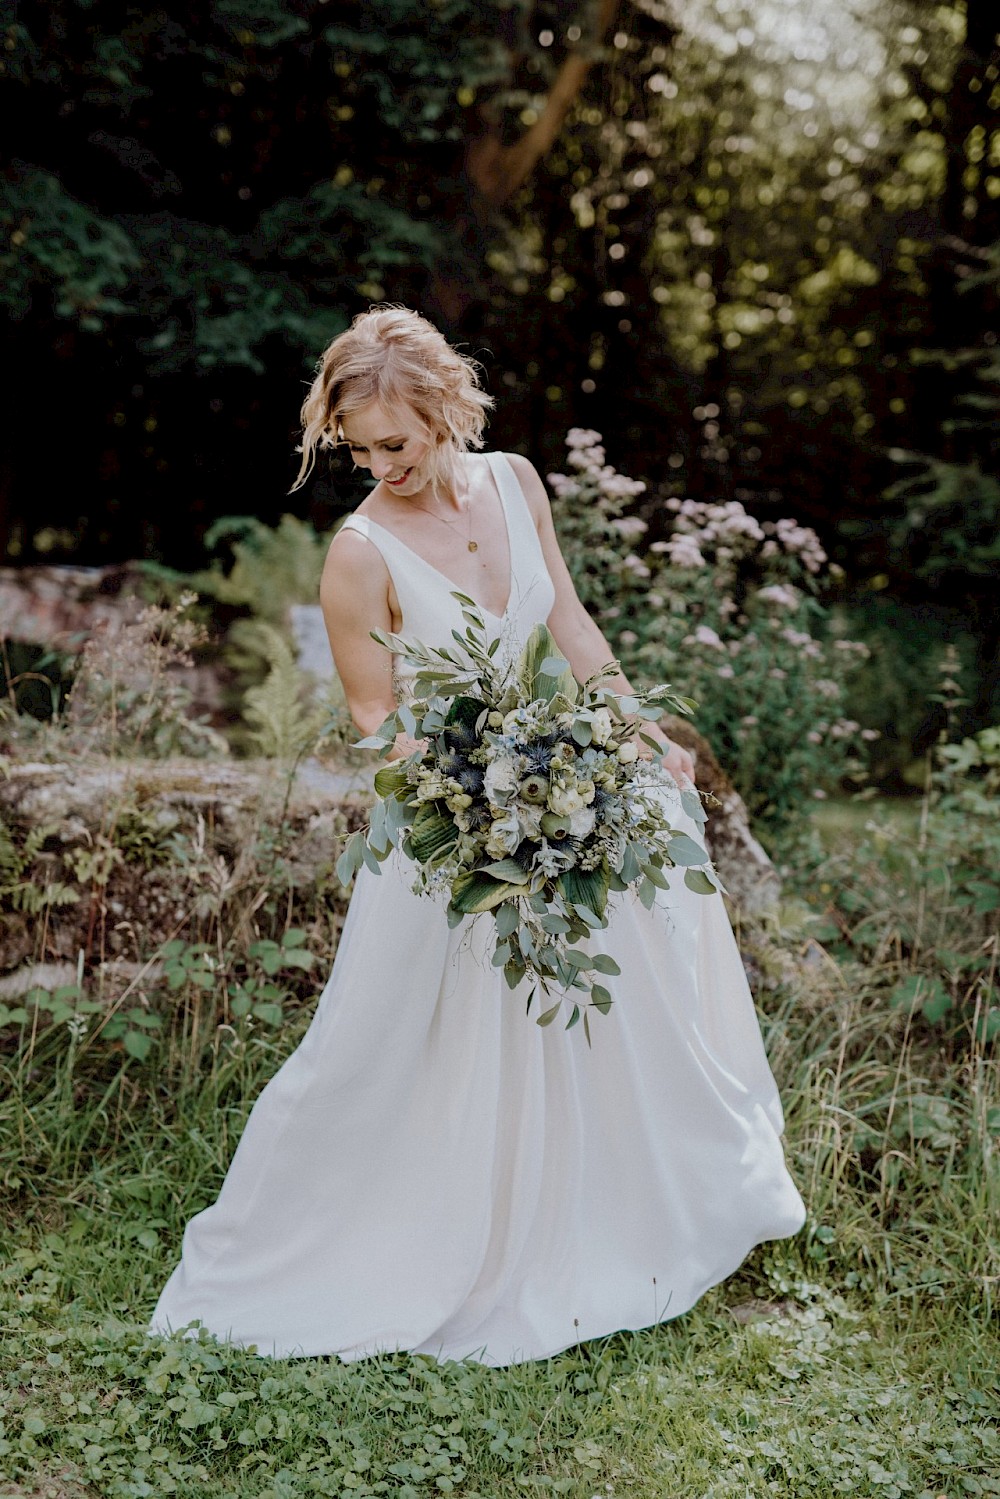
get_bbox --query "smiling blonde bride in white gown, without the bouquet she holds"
[151,307,804,1366]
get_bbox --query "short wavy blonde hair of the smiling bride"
[292,306,493,489]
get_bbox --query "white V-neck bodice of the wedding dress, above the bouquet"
[335,453,555,697]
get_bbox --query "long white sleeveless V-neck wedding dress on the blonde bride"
[151,454,804,1366]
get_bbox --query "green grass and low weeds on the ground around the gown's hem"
[0,938,1000,1499]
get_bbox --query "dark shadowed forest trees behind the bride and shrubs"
[0,0,1000,721]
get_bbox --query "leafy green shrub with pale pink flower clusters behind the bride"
[549,427,868,826]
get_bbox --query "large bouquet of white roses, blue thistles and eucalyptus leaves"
[337,594,720,1040]
